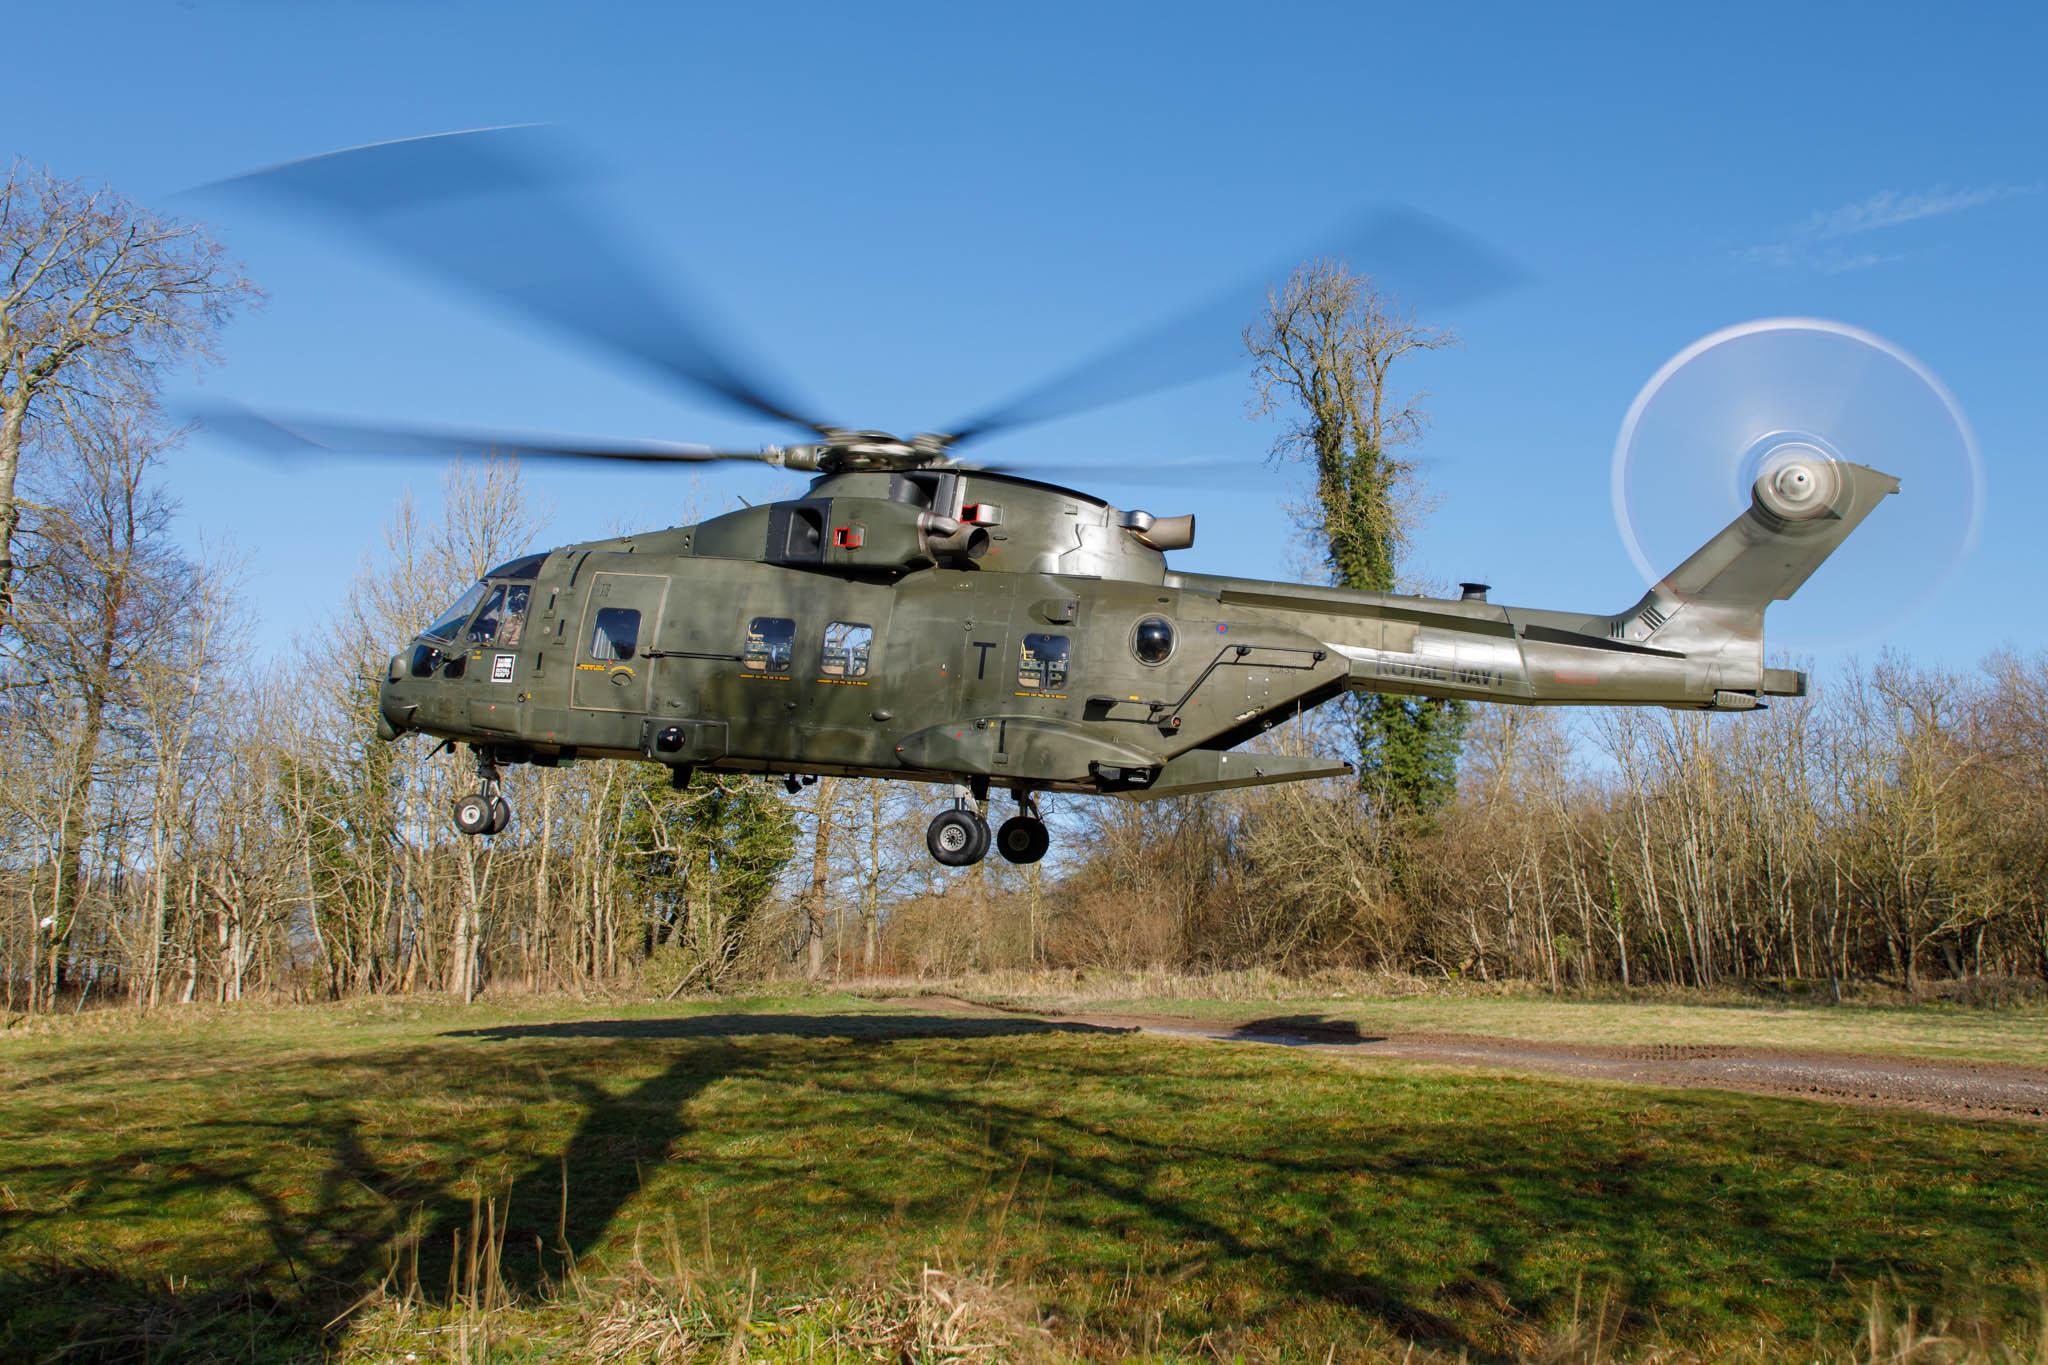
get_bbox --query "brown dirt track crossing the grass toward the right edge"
[891,997,2048,1124]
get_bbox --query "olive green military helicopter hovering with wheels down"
[209,129,1898,868]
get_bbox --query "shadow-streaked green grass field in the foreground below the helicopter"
[0,997,2048,1361]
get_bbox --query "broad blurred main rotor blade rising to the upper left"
[205,127,825,432]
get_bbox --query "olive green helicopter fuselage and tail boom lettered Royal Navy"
[381,471,1892,796]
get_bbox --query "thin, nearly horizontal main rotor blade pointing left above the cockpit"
[193,407,807,469]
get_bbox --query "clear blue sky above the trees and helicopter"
[0,0,2048,669]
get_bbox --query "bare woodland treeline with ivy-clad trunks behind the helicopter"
[0,166,2048,1011]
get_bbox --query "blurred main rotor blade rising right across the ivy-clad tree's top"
[948,207,1526,446]
